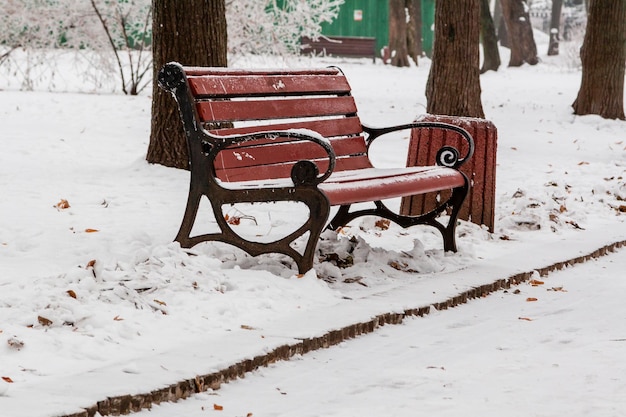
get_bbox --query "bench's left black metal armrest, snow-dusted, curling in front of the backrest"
[203,129,336,186]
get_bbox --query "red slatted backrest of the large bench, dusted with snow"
[178,67,371,181]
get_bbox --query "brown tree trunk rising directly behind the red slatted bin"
[426,0,484,118]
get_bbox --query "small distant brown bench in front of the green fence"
[300,36,377,62]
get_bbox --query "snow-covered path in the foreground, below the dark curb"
[136,249,626,417]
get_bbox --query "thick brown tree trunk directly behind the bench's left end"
[146,0,227,168]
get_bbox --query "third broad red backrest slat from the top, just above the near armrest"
[209,116,363,138]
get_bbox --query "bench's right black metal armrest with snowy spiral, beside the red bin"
[363,122,474,169]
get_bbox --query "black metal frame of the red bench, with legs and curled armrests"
[158,63,474,274]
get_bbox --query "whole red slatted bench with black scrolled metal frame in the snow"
[158,63,474,273]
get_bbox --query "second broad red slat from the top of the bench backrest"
[196,96,356,122]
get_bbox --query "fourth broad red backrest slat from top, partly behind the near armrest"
[215,137,367,169]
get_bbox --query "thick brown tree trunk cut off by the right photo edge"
[572,0,626,120]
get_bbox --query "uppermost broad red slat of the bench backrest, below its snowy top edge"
[189,74,350,98]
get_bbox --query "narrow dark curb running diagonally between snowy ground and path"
[58,240,626,417]
